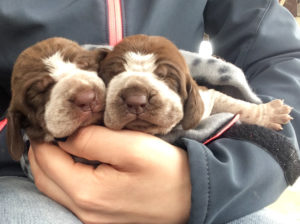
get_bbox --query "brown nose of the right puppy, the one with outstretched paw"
[125,94,148,114]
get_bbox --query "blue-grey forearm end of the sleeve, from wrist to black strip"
[179,138,287,224]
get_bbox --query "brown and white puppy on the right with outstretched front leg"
[99,35,291,134]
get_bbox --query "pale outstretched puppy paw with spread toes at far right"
[260,99,293,131]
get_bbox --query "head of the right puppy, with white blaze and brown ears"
[99,35,203,134]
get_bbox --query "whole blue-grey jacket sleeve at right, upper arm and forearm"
[181,0,300,223]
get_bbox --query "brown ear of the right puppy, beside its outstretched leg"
[181,80,204,130]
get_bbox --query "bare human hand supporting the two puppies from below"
[29,126,191,224]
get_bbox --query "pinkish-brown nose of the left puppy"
[74,90,99,112]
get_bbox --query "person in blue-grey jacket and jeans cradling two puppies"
[0,0,300,224]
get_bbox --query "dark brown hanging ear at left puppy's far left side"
[6,111,25,160]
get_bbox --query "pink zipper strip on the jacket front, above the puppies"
[106,0,123,46]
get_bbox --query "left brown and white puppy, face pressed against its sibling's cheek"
[7,37,107,160]
